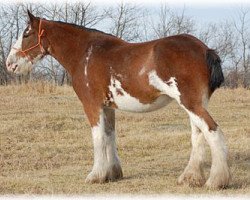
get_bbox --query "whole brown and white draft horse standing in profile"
[6,11,231,189]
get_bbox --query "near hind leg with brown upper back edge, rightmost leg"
[184,105,230,189]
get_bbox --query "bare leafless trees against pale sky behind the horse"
[0,2,250,88]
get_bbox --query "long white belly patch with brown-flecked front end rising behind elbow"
[109,77,170,112]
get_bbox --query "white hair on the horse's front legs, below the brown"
[89,111,120,176]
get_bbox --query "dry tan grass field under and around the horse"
[0,83,250,195]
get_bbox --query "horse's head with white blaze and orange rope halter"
[6,11,48,74]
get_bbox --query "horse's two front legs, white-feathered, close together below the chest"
[86,108,123,183]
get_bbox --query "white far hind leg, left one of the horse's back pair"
[178,119,205,187]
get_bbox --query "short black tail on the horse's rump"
[207,49,224,92]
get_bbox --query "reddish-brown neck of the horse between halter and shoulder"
[47,22,91,75]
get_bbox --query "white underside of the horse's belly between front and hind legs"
[114,95,171,112]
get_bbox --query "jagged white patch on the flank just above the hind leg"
[148,70,181,104]
